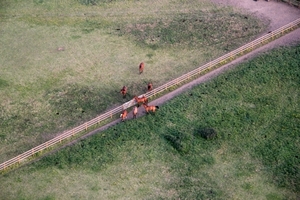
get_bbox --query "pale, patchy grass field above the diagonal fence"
[0,0,266,162]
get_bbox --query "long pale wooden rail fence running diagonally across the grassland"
[0,18,300,171]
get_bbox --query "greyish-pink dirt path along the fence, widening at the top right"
[69,0,300,142]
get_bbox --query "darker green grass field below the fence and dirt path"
[0,45,300,200]
